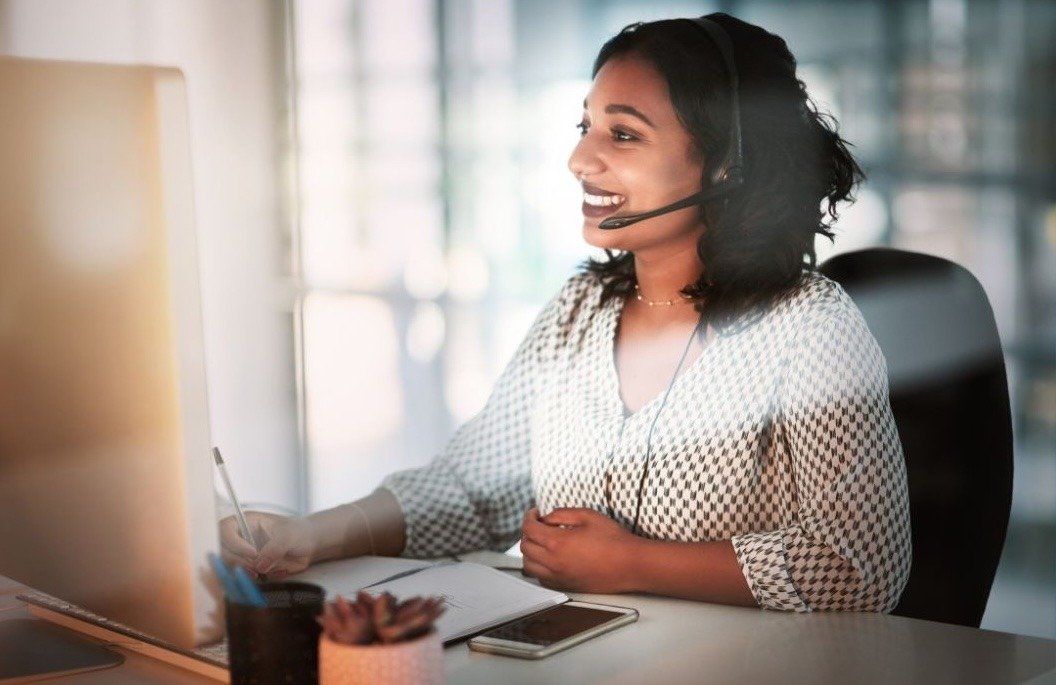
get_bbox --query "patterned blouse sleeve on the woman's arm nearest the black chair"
[733,290,911,611]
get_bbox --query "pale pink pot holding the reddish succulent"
[319,630,444,685]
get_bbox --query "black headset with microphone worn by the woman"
[599,17,744,230]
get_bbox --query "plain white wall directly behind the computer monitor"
[0,0,301,507]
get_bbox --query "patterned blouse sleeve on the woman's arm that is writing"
[381,279,578,557]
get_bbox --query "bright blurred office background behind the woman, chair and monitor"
[0,0,1056,638]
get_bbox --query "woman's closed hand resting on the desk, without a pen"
[521,508,644,594]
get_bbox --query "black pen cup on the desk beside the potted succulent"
[227,583,325,685]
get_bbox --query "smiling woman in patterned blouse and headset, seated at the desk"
[224,14,910,611]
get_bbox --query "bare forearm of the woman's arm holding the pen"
[305,488,406,564]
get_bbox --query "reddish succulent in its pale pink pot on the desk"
[319,591,444,685]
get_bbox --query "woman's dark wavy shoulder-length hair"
[584,13,864,328]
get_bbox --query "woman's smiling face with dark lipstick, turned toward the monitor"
[568,56,704,255]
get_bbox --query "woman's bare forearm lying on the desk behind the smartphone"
[623,537,758,607]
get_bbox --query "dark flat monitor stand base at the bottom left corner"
[0,619,125,685]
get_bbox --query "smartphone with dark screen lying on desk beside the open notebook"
[469,602,638,659]
